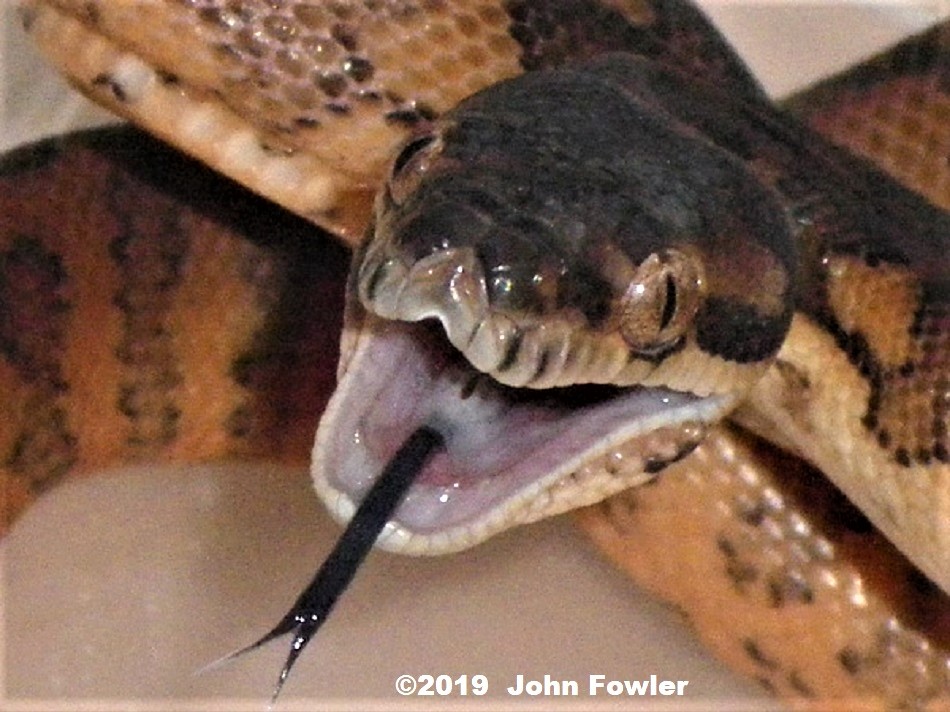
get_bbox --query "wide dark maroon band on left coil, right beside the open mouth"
[212,200,349,457]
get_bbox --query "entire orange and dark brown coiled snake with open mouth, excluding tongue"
[0,0,950,708]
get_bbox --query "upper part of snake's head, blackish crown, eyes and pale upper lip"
[357,59,795,395]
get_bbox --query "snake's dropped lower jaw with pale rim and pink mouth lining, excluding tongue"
[312,314,734,555]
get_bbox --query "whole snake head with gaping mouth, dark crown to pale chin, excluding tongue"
[314,57,794,553]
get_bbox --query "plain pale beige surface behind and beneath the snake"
[0,0,950,712]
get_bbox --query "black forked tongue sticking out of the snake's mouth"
[222,426,445,704]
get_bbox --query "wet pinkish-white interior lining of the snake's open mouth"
[321,322,699,534]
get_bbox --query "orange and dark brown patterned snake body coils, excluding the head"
[7,0,950,707]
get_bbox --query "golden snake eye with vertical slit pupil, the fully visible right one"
[620,250,704,355]
